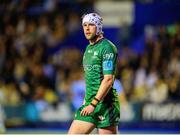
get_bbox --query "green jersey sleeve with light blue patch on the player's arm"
[102,42,117,75]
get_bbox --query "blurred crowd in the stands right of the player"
[119,23,180,103]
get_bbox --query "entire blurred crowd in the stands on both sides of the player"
[0,0,180,126]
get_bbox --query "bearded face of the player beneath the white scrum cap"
[83,23,96,40]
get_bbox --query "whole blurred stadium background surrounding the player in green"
[0,0,180,133]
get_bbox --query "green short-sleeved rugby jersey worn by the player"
[83,39,117,103]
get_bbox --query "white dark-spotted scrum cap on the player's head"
[82,13,103,35]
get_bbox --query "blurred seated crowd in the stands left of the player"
[0,0,91,125]
